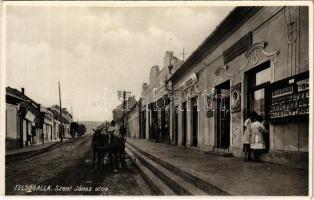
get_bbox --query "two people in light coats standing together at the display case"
[243,111,268,162]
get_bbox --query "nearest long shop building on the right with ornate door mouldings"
[169,7,309,168]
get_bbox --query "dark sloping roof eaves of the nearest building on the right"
[169,6,263,83]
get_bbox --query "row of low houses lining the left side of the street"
[6,87,72,150]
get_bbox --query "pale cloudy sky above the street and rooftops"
[6,6,233,121]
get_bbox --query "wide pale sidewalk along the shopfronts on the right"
[127,138,309,196]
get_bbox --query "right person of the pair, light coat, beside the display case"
[250,115,268,162]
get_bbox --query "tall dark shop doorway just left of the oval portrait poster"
[216,81,230,149]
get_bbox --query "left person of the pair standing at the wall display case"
[243,111,257,162]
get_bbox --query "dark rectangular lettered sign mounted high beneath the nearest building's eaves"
[223,32,252,64]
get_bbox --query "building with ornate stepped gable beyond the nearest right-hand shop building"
[139,51,183,143]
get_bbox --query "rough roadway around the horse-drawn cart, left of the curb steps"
[5,136,151,195]
